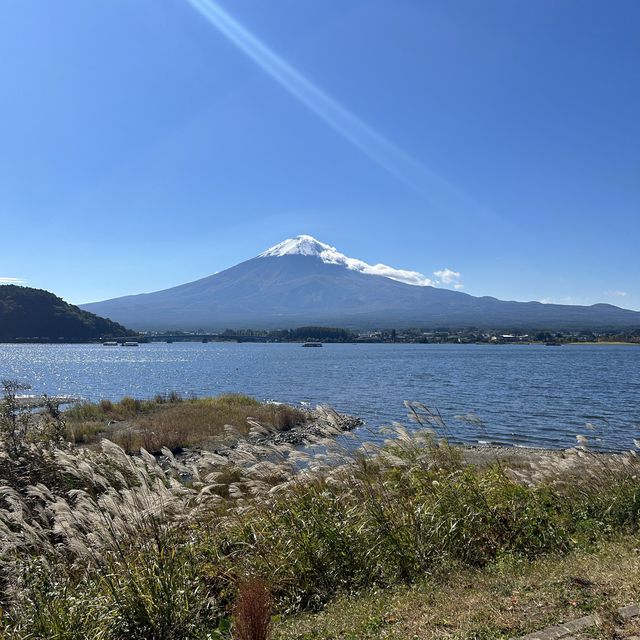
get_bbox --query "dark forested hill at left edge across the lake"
[0,285,134,342]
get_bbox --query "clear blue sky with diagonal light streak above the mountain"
[0,0,640,309]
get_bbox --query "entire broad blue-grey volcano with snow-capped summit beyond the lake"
[80,235,640,331]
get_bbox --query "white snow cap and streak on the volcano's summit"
[258,235,437,287]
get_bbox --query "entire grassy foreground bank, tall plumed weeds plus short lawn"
[0,390,640,640]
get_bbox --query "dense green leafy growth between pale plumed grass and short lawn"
[198,445,640,612]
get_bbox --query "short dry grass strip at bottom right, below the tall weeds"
[274,536,640,640]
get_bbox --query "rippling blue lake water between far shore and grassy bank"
[0,343,640,450]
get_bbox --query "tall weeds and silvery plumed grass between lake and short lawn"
[0,388,640,640]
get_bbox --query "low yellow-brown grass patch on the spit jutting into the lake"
[66,394,308,453]
